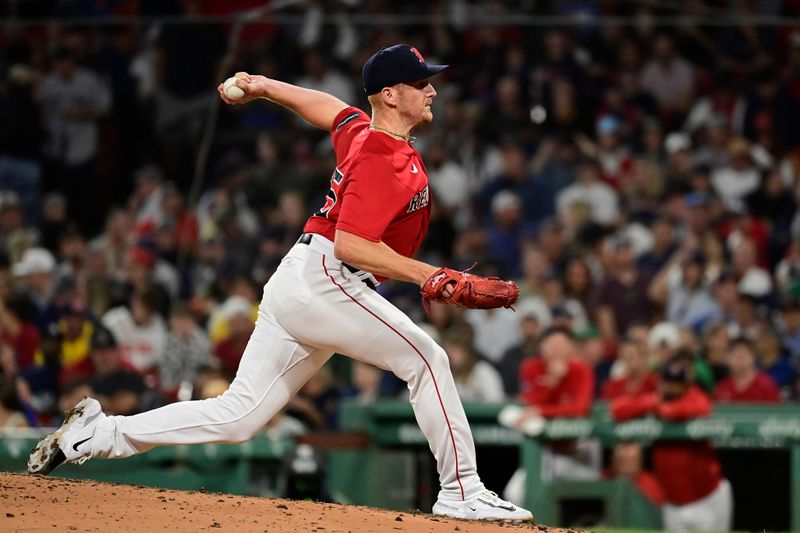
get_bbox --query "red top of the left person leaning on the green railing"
[519,357,594,418]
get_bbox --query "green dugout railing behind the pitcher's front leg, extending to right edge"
[341,402,800,531]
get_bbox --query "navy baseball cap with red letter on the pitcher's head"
[362,44,450,96]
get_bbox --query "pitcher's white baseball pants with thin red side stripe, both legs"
[92,235,484,500]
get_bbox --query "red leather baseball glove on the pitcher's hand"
[422,268,519,311]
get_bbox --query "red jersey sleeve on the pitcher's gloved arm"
[336,153,415,242]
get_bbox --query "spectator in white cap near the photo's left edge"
[11,248,58,329]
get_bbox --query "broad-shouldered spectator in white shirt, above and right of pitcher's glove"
[556,159,620,229]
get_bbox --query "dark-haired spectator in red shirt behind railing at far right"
[714,337,781,403]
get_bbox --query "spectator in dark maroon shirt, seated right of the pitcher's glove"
[592,236,654,344]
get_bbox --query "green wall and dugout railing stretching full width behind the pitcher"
[0,401,800,531]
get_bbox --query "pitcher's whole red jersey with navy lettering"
[303,107,431,279]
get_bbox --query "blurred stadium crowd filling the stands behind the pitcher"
[0,0,800,531]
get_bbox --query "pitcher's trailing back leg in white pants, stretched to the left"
[92,313,331,457]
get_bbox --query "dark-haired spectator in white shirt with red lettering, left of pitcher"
[101,287,168,374]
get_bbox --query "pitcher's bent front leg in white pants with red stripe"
[280,262,485,500]
